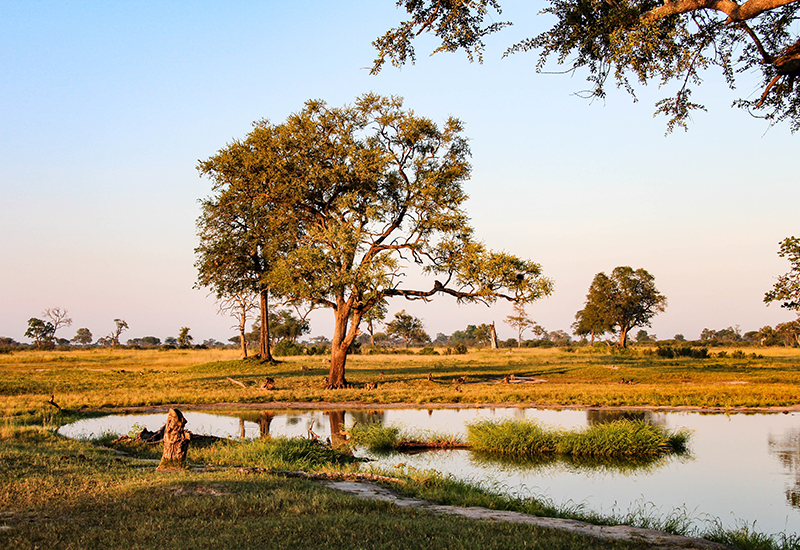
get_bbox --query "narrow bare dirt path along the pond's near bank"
[325,481,730,550]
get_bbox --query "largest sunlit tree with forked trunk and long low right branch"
[198,94,552,388]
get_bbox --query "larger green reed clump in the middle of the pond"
[467,419,689,459]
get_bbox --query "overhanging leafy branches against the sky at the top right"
[372,0,800,131]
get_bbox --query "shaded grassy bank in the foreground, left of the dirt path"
[0,423,643,550]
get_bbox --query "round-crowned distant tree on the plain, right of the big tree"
[575,266,667,348]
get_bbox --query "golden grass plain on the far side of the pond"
[0,348,800,416]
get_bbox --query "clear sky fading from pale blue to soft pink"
[0,0,800,342]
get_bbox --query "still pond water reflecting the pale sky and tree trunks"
[60,408,800,534]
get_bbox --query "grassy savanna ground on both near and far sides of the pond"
[0,346,800,548]
